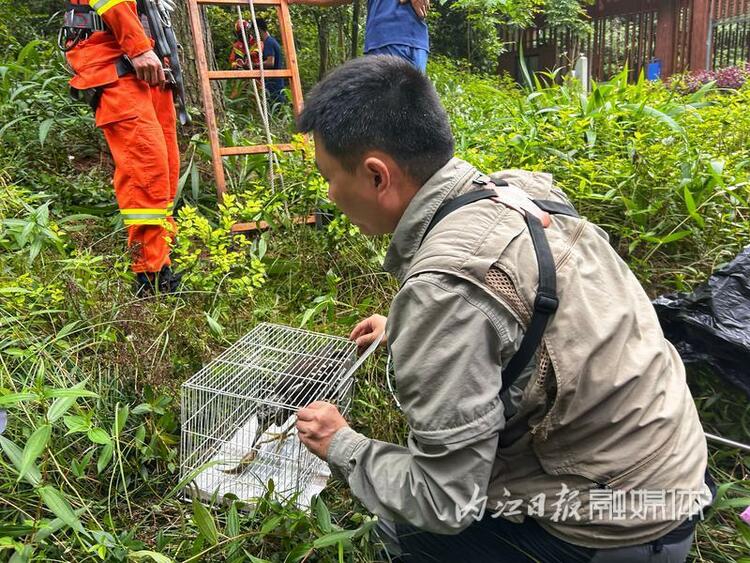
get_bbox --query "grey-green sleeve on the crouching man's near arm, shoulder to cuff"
[314,274,518,534]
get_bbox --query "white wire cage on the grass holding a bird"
[180,323,360,507]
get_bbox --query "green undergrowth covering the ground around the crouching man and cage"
[0,42,750,563]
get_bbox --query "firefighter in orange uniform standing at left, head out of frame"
[61,0,180,293]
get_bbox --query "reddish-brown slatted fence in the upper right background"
[499,0,750,80]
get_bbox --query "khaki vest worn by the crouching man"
[405,168,711,547]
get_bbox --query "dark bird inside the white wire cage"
[222,347,352,475]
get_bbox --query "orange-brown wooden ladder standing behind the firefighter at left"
[187,0,302,200]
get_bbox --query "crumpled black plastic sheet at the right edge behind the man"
[653,246,750,397]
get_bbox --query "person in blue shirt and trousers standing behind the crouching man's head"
[288,0,430,72]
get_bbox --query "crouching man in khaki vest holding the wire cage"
[297,56,712,563]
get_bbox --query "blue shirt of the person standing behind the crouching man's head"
[365,0,430,53]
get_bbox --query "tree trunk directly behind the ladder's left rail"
[172,1,224,121]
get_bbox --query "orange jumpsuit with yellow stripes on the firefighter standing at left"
[67,0,180,273]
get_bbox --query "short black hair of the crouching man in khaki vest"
[297,55,453,185]
